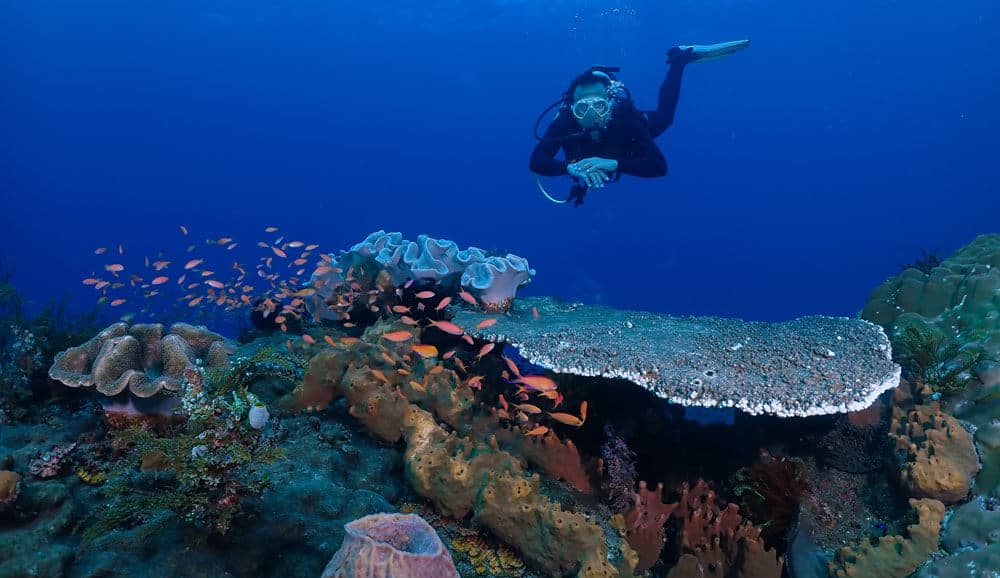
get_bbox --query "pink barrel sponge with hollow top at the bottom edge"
[322,514,458,578]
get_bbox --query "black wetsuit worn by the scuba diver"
[530,62,686,177]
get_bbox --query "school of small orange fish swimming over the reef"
[83,225,587,436]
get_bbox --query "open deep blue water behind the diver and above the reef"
[0,0,1000,328]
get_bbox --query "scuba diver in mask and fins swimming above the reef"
[529,40,750,207]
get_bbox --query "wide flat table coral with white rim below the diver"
[452,297,899,417]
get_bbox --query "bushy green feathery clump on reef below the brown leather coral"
[83,362,284,546]
